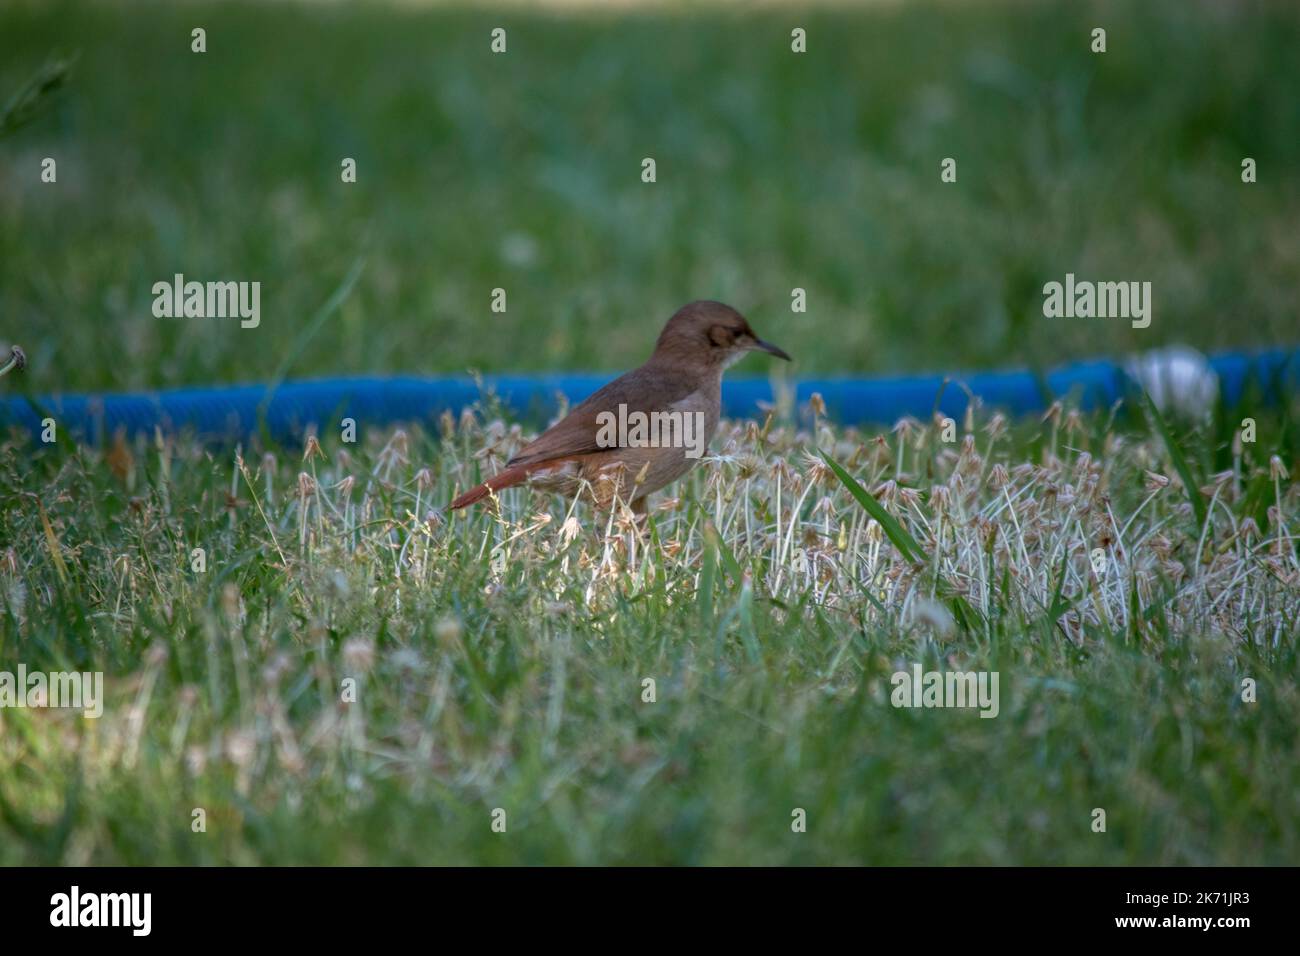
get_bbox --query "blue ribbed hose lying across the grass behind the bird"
[0,350,1300,444]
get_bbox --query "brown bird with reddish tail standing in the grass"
[451,302,790,512]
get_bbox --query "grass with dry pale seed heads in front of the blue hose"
[0,398,1300,864]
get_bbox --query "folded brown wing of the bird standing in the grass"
[506,365,698,467]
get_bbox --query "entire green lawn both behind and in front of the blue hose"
[0,3,1300,865]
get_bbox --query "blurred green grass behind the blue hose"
[0,0,1300,392]
